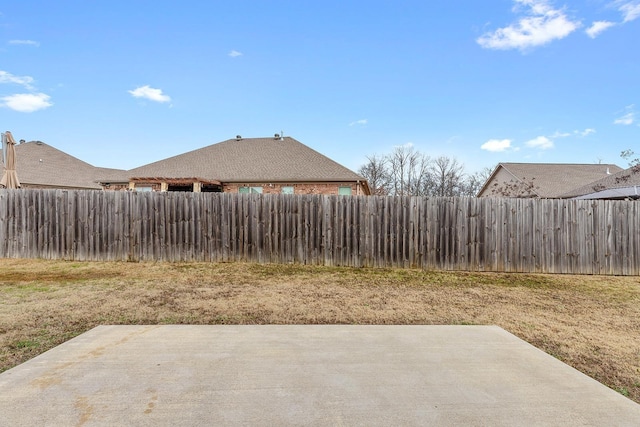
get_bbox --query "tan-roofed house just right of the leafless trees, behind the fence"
[478,163,622,199]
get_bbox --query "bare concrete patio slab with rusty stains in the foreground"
[0,325,640,426]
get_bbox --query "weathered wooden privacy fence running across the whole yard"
[0,189,640,275]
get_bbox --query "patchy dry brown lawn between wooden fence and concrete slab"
[0,259,640,402]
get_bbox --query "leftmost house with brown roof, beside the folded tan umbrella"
[0,140,124,190]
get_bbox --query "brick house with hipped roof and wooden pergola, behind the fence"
[99,134,370,195]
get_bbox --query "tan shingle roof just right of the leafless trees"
[482,163,622,198]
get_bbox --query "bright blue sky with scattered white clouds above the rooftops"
[0,0,640,172]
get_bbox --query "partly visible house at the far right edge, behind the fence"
[562,165,640,200]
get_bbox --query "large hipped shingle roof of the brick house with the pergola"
[128,137,364,182]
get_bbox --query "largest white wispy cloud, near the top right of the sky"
[476,0,581,50]
